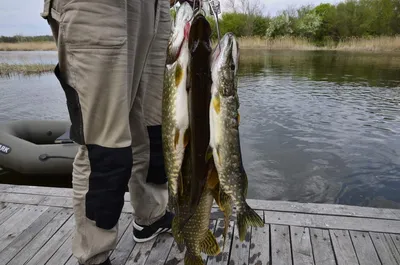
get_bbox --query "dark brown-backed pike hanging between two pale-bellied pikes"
[189,13,212,209]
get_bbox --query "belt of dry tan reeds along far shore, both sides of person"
[0,36,400,52]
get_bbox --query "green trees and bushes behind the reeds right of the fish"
[205,0,400,45]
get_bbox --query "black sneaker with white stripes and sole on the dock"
[133,211,174,243]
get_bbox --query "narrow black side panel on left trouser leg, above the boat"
[54,64,85,145]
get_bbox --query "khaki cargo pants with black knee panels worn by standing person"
[41,0,171,264]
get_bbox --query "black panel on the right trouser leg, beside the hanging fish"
[146,125,168,185]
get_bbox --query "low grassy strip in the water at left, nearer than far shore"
[0,63,54,77]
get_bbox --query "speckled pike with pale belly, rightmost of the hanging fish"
[207,33,264,241]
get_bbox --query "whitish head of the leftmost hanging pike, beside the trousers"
[167,2,193,64]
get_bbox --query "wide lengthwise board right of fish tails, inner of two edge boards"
[264,211,400,233]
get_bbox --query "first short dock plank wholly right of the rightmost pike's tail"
[271,224,293,265]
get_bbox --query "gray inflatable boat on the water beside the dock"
[0,120,78,175]
